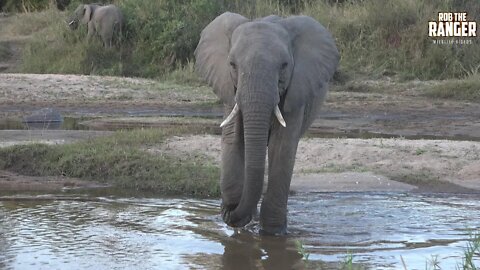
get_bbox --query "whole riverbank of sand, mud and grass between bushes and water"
[0,74,480,197]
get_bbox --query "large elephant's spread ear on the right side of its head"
[278,16,340,112]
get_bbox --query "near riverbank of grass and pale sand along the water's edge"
[0,128,480,197]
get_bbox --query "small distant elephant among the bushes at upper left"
[68,4,123,48]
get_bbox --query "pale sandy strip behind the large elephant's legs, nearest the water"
[158,135,480,192]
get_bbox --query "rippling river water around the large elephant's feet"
[0,193,480,269]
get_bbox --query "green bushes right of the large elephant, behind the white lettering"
[305,0,480,79]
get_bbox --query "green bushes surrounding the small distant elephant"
[22,0,221,77]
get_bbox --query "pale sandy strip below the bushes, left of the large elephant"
[0,73,215,110]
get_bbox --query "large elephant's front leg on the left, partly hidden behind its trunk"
[220,108,245,220]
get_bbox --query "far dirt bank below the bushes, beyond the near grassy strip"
[0,74,480,140]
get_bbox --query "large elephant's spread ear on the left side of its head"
[195,12,248,106]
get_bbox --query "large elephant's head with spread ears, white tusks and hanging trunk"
[195,12,339,227]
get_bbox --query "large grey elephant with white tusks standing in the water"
[195,12,340,235]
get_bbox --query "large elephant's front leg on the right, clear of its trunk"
[260,108,303,235]
